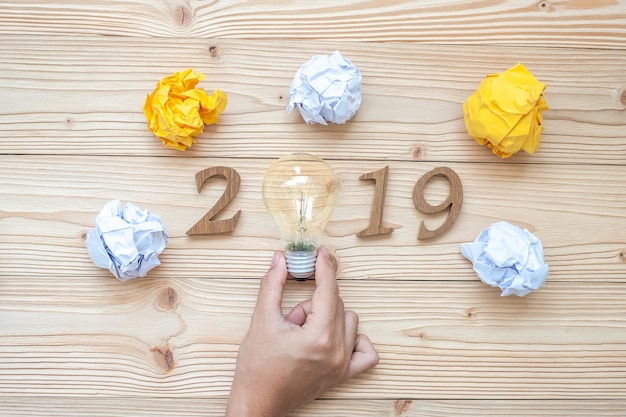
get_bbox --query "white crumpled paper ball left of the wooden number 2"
[86,200,167,281]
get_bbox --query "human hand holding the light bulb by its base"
[226,247,378,417]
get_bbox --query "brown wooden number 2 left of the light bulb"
[187,167,241,235]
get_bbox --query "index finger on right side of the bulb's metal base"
[311,246,343,322]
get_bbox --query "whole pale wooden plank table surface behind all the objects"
[0,0,626,417]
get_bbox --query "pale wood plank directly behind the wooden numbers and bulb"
[0,155,626,282]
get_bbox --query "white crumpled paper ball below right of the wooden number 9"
[461,221,548,297]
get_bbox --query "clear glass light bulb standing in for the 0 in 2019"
[263,153,337,280]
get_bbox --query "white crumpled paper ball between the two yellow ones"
[287,51,361,125]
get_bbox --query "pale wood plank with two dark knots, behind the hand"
[0,276,626,401]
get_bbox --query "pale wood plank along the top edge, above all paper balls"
[0,0,626,49]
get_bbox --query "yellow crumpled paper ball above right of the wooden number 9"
[463,64,548,158]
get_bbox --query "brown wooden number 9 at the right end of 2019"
[413,167,463,239]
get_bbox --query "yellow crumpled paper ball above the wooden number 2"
[143,68,228,151]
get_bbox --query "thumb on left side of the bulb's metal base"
[255,251,287,315]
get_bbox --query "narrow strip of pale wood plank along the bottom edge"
[0,397,626,417]
